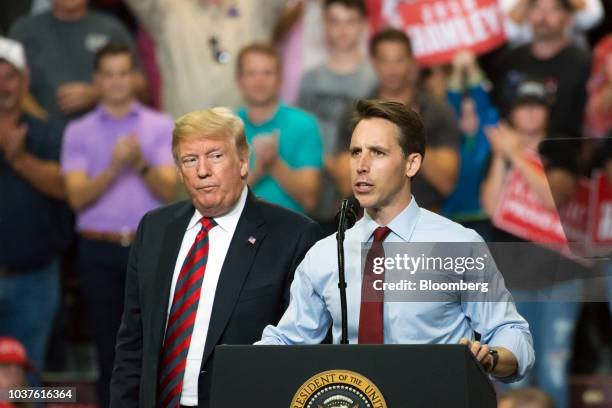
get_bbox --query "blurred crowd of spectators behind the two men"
[0,0,612,408]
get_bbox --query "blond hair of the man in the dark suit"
[172,107,249,163]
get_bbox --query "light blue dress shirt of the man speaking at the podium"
[258,197,534,381]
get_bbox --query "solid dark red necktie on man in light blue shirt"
[358,227,391,344]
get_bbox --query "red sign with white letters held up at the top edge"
[386,0,506,65]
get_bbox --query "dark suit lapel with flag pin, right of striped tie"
[202,191,266,366]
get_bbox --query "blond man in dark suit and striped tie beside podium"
[110,108,319,408]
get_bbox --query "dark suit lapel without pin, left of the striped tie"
[151,203,194,355]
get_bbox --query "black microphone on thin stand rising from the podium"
[336,197,360,344]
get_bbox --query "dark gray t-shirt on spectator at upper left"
[9,11,133,122]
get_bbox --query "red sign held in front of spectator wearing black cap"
[492,152,567,243]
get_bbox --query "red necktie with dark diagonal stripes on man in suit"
[157,218,216,408]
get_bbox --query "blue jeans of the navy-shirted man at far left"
[0,259,61,374]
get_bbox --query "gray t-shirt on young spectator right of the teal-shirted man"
[298,63,376,221]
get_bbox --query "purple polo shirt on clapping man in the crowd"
[61,103,174,232]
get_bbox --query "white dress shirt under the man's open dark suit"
[166,187,248,406]
